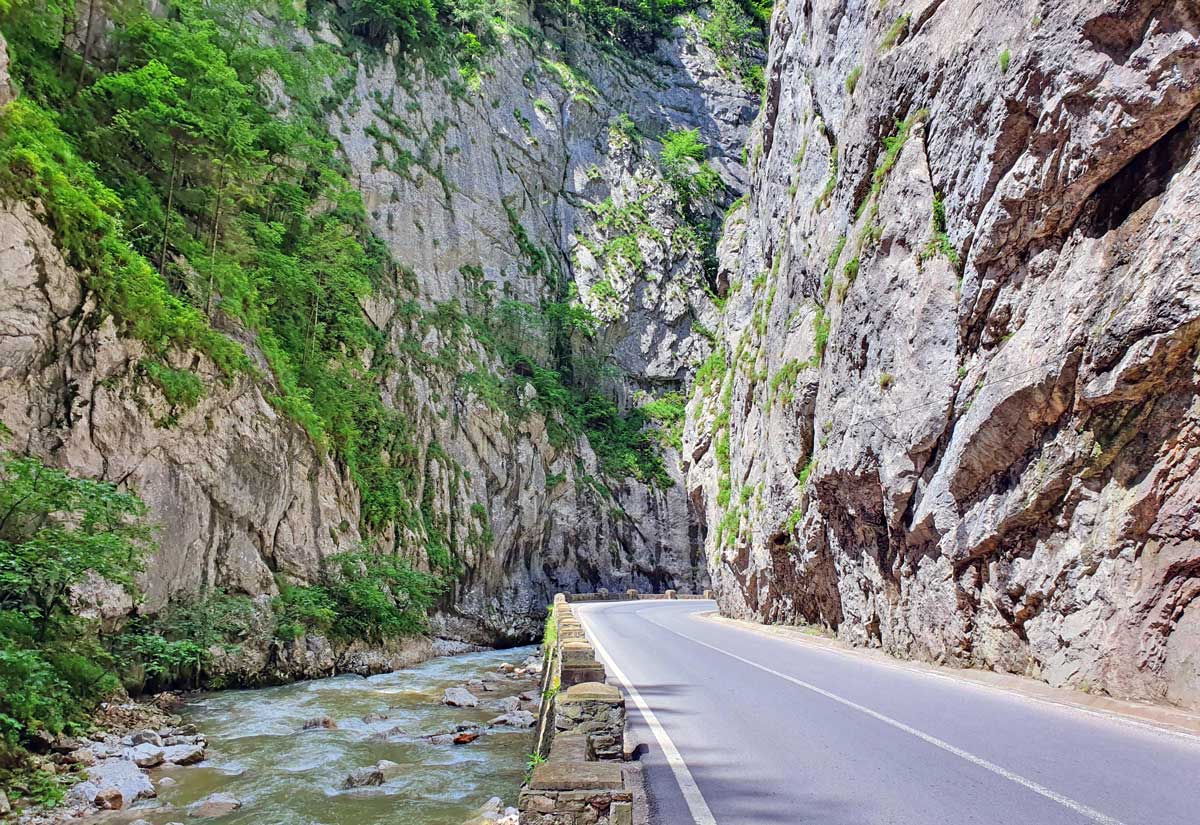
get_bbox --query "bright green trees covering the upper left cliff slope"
[0,0,453,544]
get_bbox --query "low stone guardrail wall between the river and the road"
[517,590,712,825]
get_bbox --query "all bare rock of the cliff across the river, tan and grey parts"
[0,9,755,642]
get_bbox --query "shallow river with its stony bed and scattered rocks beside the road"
[22,648,540,825]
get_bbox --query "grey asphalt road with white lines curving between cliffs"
[575,601,1200,825]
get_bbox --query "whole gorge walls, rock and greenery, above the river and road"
[0,0,1200,815]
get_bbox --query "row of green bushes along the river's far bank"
[0,453,442,801]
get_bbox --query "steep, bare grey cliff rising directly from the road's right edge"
[684,0,1200,706]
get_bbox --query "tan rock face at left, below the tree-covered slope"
[0,204,359,612]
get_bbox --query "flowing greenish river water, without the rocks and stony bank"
[113,648,538,825]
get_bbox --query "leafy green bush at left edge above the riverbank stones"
[0,453,152,799]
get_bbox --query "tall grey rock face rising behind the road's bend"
[307,11,755,640]
